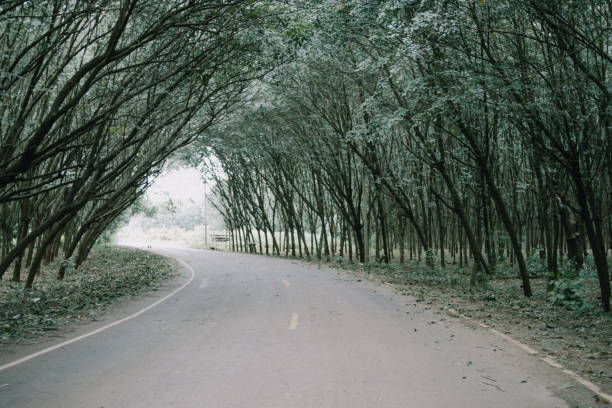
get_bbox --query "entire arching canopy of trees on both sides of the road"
[0,0,612,311]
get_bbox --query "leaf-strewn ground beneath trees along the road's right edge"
[328,262,612,400]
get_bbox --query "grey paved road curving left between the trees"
[0,248,592,408]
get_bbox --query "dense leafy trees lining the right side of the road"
[193,0,612,312]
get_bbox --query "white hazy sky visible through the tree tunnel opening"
[146,168,210,204]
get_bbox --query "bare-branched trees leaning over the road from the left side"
[0,0,273,286]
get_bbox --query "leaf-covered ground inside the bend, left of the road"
[0,247,175,346]
